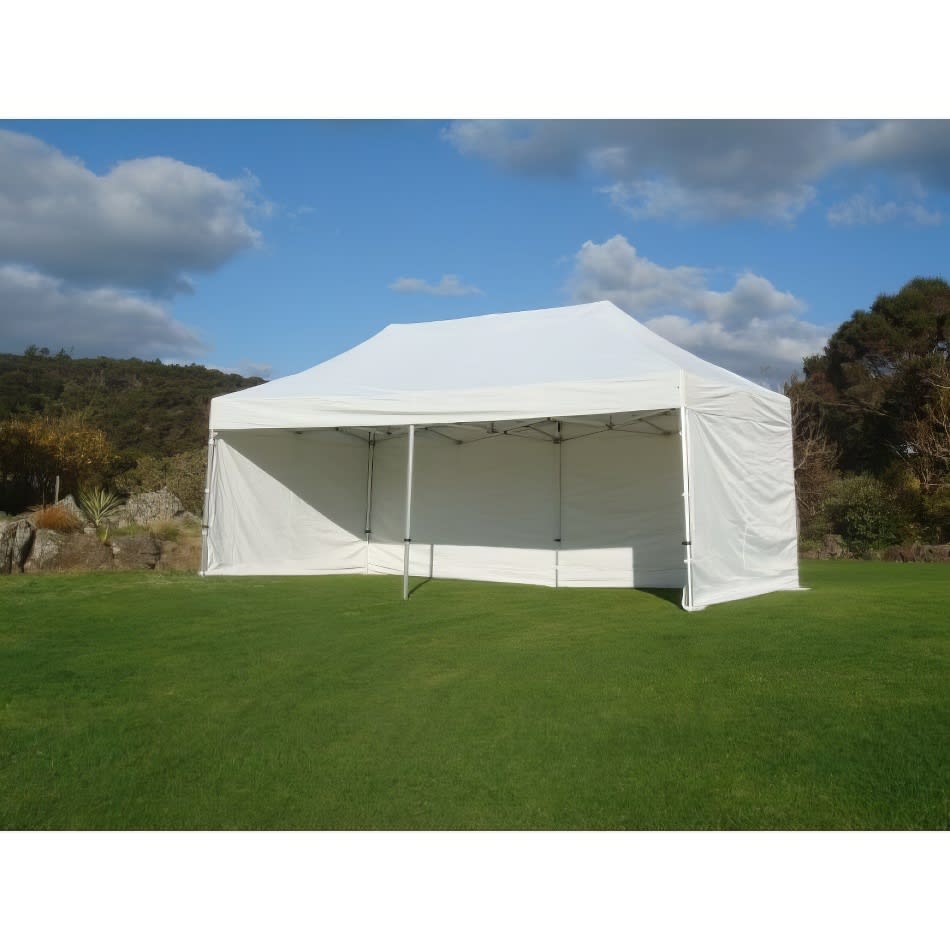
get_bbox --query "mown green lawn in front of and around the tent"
[0,562,950,829]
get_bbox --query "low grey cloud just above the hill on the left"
[0,264,208,361]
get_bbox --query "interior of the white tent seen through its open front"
[211,410,685,588]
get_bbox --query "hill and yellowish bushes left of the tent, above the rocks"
[0,346,263,511]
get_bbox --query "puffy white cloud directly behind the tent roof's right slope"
[569,235,827,387]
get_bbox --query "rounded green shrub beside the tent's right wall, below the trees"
[823,475,904,555]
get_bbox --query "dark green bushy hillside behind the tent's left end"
[0,347,263,459]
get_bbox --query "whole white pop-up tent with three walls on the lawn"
[202,302,798,610]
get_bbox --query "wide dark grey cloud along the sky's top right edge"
[444,120,950,224]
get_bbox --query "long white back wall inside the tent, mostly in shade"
[369,429,685,588]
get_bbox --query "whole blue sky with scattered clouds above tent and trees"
[0,120,950,385]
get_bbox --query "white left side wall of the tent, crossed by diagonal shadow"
[207,430,366,574]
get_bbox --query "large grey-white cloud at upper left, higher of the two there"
[0,130,260,293]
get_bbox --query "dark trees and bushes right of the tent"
[785,277,950,554]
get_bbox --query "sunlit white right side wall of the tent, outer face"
[687,378,799,608]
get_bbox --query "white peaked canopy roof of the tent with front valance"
[211,301,784,429]
